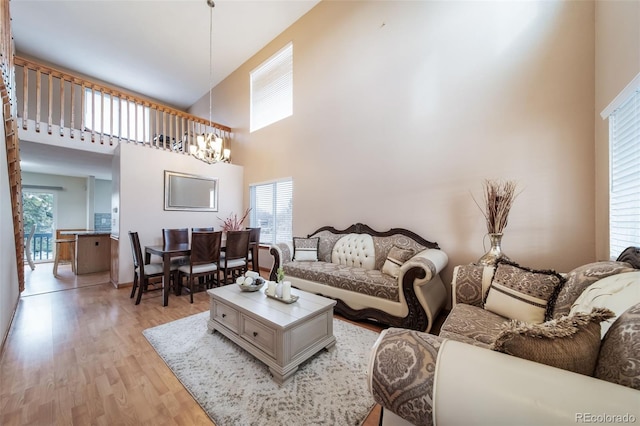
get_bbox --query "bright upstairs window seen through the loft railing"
[84,88,149,142]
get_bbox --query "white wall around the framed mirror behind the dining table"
[114,143,248,285]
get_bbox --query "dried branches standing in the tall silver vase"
[473,179,518,234]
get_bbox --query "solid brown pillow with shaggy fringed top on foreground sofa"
[491,308,615,376]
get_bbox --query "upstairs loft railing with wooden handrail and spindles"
[15,56,231,153]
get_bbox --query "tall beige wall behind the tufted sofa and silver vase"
[191,1,595,290]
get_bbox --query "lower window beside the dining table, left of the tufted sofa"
[249,178,293,244]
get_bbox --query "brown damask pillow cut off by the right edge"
[594,303,640,390]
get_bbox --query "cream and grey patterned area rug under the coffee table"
[143,312,378,426]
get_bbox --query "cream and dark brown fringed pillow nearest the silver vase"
[484,260,565,323]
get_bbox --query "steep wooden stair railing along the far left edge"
[0,0,24,291]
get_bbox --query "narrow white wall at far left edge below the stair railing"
[0,106,19,350]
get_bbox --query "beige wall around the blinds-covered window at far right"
[595,0,640,259]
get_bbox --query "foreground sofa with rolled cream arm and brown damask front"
[369,247,640,425]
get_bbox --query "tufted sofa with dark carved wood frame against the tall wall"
[270,224,448,331]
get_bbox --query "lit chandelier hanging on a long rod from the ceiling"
[189,0,231,164]
